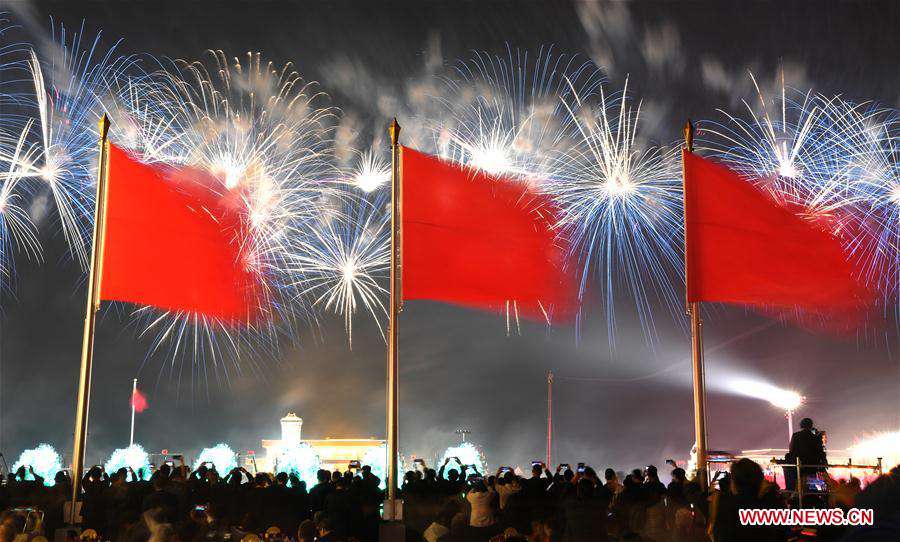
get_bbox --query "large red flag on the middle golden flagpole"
[401,147,577,319]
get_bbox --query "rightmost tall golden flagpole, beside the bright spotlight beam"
[681,120,709,490]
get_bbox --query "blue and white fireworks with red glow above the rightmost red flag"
[701,75,900,328]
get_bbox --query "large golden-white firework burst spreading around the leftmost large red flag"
[111,51,332,382]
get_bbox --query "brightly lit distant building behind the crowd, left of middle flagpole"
[246,412,384,471]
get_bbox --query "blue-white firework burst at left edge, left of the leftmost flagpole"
[0,21,129,288]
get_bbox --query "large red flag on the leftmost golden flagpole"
[100,145,262,322]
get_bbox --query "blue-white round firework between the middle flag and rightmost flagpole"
[546,81,683,344]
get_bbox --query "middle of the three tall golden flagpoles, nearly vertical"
[384,118,402,521]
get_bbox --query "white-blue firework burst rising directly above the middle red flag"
[432,48,604,184]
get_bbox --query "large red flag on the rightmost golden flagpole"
[683,152,873,324]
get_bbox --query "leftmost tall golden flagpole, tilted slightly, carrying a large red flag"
[70,114,109,524]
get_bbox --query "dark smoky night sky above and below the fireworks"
[0,1,900,476]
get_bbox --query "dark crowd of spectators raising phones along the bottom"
[0,459,900,542]
